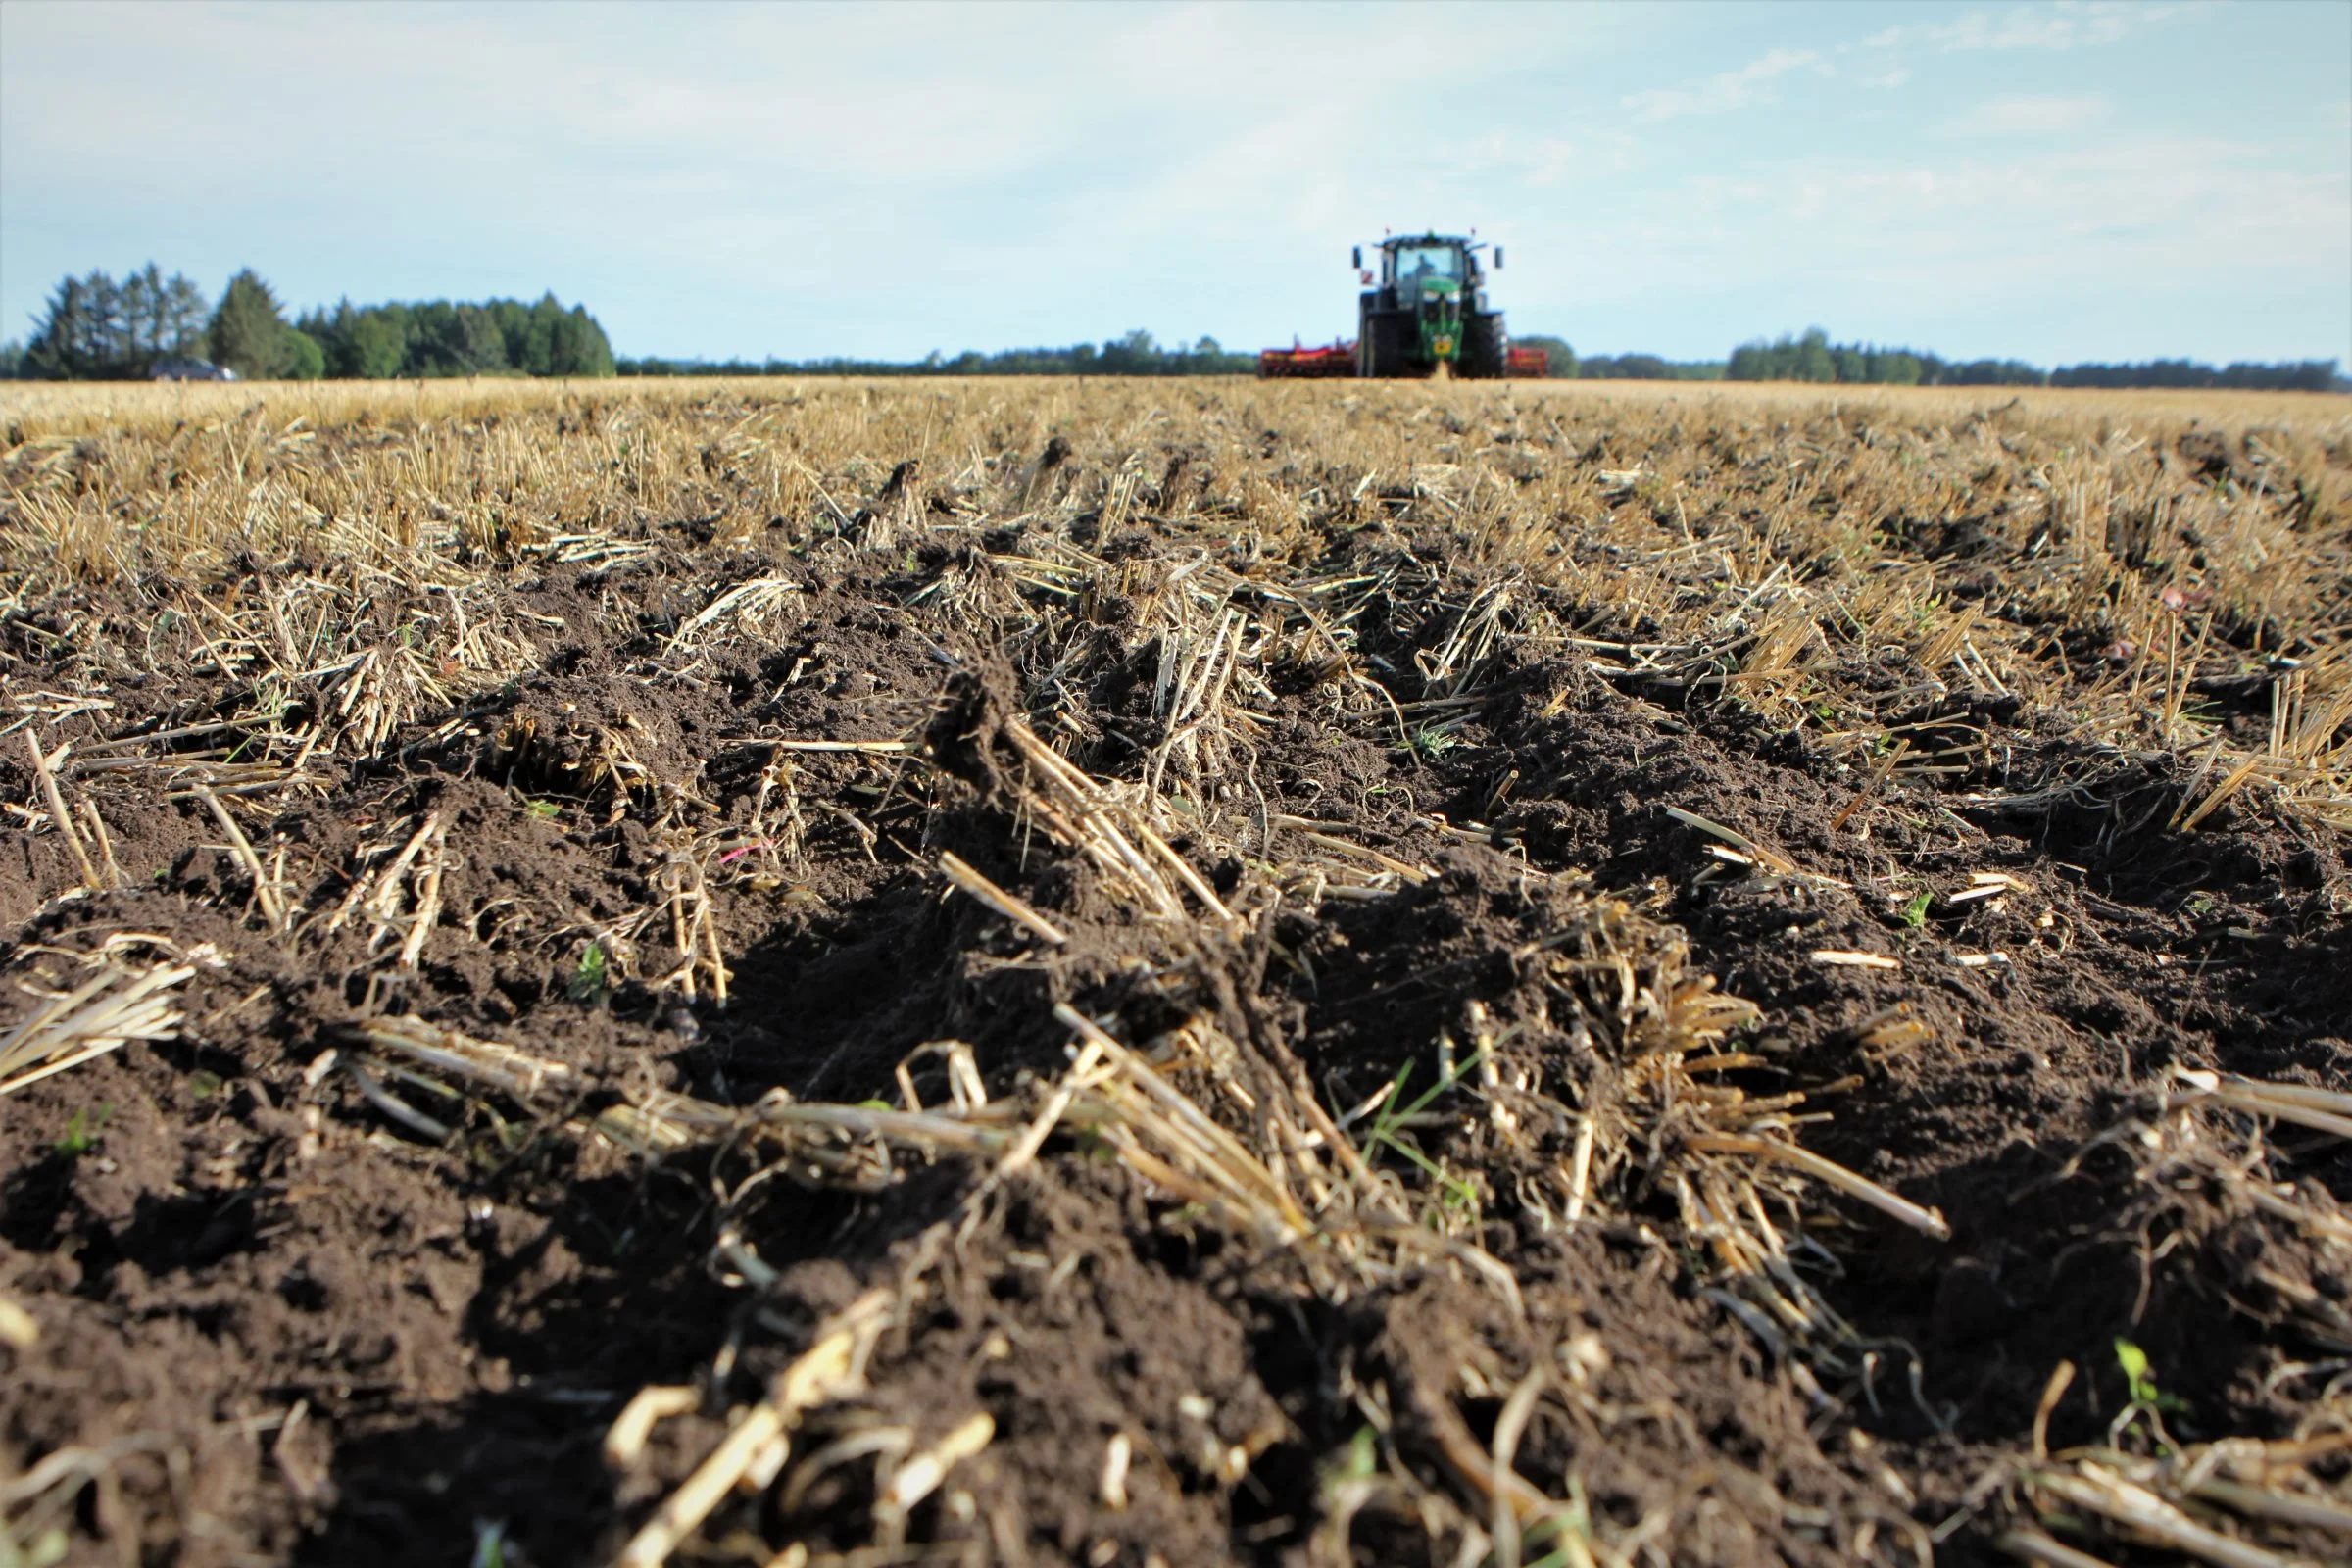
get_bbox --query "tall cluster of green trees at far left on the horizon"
[0,261,613,381]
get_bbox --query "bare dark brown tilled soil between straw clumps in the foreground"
[0,432,2352,1568]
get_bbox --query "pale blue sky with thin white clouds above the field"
[0,0,2352,365]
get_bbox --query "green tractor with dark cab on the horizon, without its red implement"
[1354,235,1541,381]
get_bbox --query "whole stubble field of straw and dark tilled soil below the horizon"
[0,381,2352,1568]
